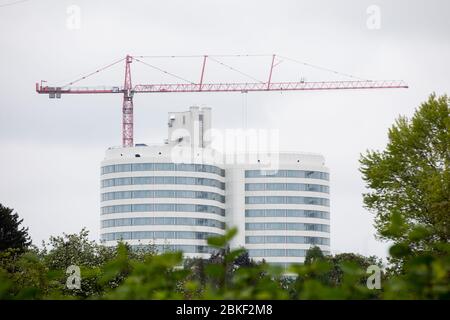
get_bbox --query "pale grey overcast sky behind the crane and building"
[0,0,450,256]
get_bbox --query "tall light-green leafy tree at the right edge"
[360,94,450,252]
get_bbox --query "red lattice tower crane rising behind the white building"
[36,55,408,147]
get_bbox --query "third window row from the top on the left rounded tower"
[102,190,225,203]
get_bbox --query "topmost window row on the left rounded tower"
[102,163,225,177]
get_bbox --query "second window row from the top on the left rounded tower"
[102,176,225,190]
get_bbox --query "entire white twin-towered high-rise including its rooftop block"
[100,107,330,265]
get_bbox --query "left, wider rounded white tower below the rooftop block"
[100,145,225,258]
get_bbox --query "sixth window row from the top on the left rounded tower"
[100,231,220,241]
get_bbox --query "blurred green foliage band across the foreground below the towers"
[0,219,450,299]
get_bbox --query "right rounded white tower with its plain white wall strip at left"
[227,153,330,266]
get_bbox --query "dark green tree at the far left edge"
[0,204,31,252]
